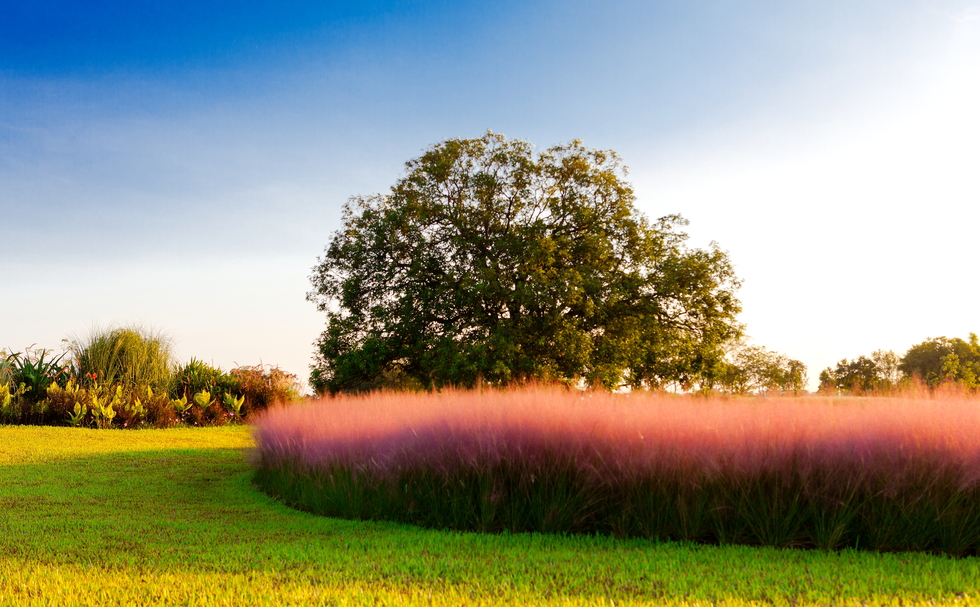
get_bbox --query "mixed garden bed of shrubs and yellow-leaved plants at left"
[0,329,300,428]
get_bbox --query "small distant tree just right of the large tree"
[713,343,807,394]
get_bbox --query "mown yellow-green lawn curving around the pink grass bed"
[0,427,980,605]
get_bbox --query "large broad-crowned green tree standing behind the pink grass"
[307,132,740,392]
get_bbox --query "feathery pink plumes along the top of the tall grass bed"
[256,389,980,488]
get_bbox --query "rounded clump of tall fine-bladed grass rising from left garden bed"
[72,327,173,390]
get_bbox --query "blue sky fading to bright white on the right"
[0,0,980,387]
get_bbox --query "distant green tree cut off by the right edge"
[898,333,980,388]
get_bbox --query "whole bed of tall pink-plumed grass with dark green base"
[255,389,980,555]
